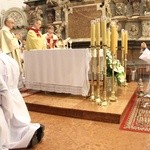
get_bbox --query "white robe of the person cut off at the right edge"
[139,48,150,97]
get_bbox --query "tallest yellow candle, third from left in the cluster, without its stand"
[101,17,107,45]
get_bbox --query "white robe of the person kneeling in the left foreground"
[0,52,40,150]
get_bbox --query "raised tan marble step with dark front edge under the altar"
[24,82,137,124]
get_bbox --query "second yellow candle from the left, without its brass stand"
[95,18,100,45]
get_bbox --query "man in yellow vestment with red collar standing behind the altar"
[26,19,46,50]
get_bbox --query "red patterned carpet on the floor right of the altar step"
[120,92,150,133]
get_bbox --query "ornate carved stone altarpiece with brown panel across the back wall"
[1,0,150,47]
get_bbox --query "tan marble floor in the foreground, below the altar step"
[30,112,150,150]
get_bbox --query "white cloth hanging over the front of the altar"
[24,49,91,96]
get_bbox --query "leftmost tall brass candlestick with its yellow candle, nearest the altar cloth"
[90,20,95,100]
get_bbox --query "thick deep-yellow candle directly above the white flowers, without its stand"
[111,24,117,54]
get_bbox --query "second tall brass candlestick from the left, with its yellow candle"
[95,18,101,105]
